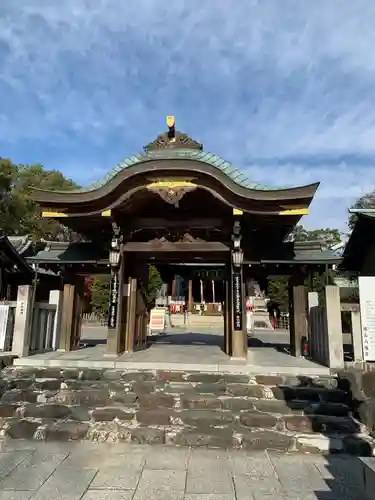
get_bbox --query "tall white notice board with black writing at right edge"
[358,276,375,361]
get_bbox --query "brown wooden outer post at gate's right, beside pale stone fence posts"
[289,275,308,357]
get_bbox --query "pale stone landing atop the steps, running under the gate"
[14,330,329,376]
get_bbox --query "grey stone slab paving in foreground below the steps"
[0,442,365,500]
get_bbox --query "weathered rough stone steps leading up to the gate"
[0,367,373,456]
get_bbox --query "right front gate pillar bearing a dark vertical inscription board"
[231,219,247,358]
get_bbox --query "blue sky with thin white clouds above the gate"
[0,0,375,231]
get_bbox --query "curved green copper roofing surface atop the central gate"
[80,148,274,191]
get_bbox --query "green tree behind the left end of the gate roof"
[0,159,78,240]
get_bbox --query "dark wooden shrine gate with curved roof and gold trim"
[32,120,340,359]
